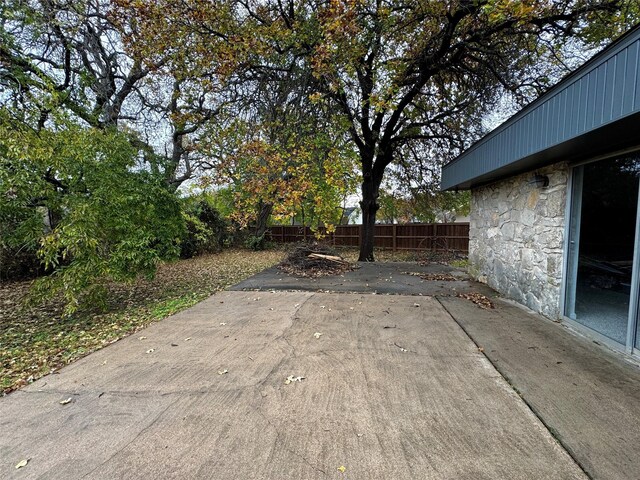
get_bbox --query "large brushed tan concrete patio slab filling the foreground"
[0,292,586,480]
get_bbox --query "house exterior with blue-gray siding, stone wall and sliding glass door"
[441,26,640,354]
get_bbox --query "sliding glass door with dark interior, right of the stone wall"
[565,154,640,349]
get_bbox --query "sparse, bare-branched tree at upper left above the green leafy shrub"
[0,0,222,190]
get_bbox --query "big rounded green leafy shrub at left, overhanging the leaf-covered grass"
[0,111,184,313]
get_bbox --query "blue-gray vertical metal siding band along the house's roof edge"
[441,27,640,190]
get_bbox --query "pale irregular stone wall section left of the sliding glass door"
[469,163,569,319]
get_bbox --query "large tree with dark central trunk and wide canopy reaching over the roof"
[122,0,637,261]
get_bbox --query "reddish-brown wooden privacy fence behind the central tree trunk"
[267,223,469,253]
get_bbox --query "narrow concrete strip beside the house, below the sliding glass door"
[439,297,640,480]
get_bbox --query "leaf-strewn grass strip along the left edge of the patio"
[0,250,282,394]
